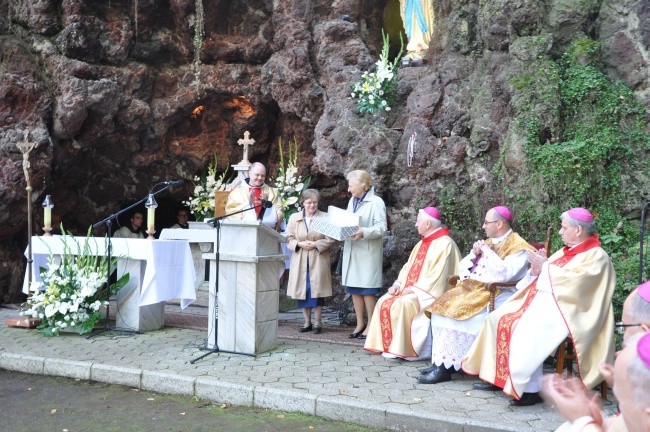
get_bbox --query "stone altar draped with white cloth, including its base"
[23,236,196,331]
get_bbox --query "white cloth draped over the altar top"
[23,236,196,309]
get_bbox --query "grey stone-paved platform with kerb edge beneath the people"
[0,306,615,432]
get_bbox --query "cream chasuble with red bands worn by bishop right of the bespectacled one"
[462,235,616,398]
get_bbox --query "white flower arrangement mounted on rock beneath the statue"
[350,30,404,114]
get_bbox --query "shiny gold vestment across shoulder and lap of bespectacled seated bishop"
[427,232,535,320]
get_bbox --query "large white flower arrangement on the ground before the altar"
[21,227,129,336]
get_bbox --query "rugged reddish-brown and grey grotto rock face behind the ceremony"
[0,0,650,302]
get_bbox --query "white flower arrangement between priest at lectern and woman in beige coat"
[274,138,311,220]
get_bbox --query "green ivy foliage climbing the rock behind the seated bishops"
[494,39,650,314]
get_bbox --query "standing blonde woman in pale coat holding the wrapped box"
[341,170,387,339]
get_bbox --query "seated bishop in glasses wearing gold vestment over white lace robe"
[418,206,535,384]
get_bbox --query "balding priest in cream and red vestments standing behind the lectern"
[226,162,284,221]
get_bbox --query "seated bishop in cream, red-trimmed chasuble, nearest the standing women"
[364,207,460,359]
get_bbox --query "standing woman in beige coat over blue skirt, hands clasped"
[287,189,335,334]
